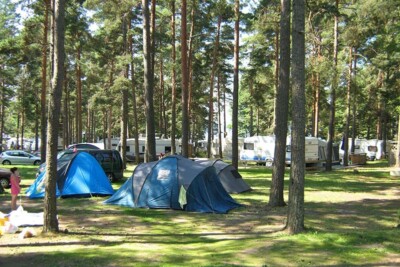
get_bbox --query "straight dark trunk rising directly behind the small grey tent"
[231,0,240,169]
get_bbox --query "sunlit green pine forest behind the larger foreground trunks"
[0,0,400,163]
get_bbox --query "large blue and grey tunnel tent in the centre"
[104,155,240,213]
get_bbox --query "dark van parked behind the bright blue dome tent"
[37,149,125,182]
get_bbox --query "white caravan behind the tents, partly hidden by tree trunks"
[117,138,180,161]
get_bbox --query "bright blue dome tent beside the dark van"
[26,152,114,198]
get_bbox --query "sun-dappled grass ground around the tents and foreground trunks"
[0,161,400,266]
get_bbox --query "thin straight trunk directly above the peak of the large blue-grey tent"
[171,0,177,154]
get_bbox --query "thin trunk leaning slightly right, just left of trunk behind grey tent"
[207,15,222,158]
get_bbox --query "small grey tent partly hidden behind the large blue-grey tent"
[196,159,251,193]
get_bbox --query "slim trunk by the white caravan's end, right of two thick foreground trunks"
[325,0,339,171]
